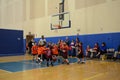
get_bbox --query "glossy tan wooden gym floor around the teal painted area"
[0,55,120,80]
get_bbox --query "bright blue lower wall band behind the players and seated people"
[32,32,120,50]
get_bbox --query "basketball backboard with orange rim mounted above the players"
[50,12,71,30]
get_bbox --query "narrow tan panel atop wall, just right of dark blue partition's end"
[30,0,45,19]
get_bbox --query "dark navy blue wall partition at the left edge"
[0,29,24,56]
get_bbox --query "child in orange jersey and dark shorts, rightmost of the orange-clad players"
[61,42,69,64]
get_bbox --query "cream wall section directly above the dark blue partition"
[0,0,25,30]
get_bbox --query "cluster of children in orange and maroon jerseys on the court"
[31,37,85,66]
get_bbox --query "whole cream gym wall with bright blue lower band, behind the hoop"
[0,0,120,55]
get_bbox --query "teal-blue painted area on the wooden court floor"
[0,58,76,73]
